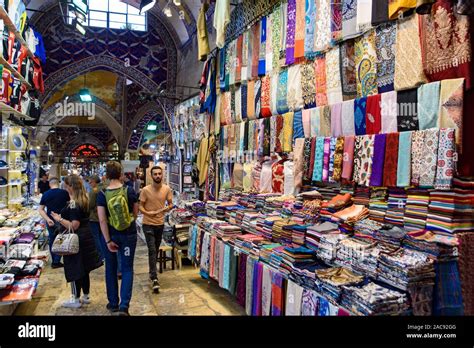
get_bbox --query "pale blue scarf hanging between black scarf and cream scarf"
[417,82,441,129]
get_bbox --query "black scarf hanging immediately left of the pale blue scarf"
[397,88,418,132]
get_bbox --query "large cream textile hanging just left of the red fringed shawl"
[394,14,427,91]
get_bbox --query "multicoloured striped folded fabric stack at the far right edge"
[426,188,474,233]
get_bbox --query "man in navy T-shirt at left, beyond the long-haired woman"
[39,177,69,268]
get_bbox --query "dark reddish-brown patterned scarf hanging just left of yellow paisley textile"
[339,40,357,100]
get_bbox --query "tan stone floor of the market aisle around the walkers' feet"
[15,240,245,315]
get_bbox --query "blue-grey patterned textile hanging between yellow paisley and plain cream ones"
[375,23,397,93]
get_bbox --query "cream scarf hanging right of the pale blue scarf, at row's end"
[438,79,464,153]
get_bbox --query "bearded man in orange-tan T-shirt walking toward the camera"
[139,166,173,292]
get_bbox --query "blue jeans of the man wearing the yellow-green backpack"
[101,233,137,310]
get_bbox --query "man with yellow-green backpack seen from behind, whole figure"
[97,161,138,315]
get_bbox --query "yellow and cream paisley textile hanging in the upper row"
[355,30,378,97]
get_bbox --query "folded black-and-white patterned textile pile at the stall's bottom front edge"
[341,282,409,315]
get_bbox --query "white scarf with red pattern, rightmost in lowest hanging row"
[434,128,456,190]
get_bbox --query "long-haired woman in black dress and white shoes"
[51,175,103,308]
